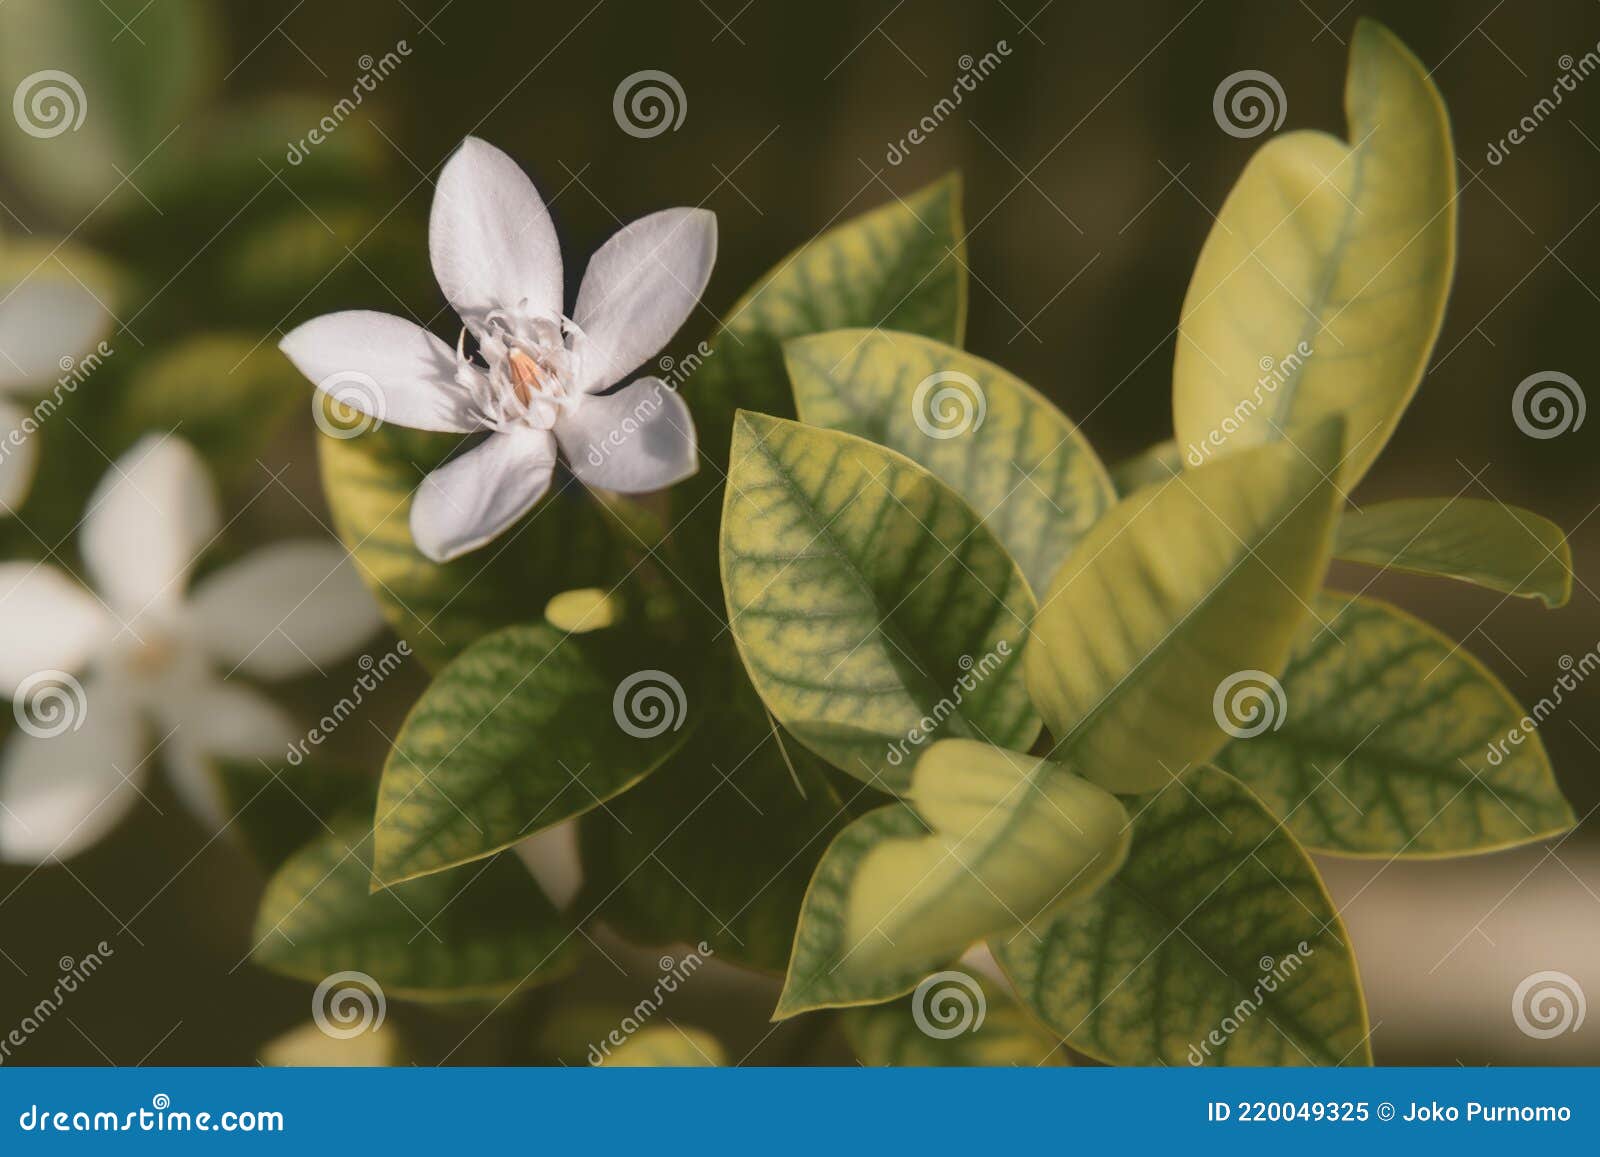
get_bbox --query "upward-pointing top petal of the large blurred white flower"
[80,435,221,619]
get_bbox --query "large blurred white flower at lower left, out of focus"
[0,437,379,863]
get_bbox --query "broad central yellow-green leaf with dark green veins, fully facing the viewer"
[722,413,1038,789]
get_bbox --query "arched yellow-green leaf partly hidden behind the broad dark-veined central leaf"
[784,330,1115,591]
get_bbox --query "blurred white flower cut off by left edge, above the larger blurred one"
[0,258,110,515]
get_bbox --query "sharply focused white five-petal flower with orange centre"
[282,138,717,562]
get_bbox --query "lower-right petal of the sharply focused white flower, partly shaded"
[555,378,699,494]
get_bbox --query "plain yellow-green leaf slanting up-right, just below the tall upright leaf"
[1026,421,1341,792]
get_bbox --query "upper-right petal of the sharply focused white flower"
[573,210,717,394]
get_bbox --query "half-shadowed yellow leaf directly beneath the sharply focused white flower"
[318,419,632,671]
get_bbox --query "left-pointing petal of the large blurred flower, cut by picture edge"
[0,562,115,696]
